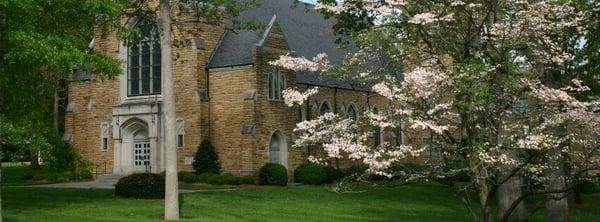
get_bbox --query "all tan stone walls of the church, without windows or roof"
[65,14,421,179]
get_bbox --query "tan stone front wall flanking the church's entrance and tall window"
[65,15,224,171]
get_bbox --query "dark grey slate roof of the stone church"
[208,0,360,88]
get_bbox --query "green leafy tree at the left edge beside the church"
[0,0,126,166]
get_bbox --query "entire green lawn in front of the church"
[3,185,600,222]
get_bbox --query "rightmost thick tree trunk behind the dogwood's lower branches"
[545,148,569,222]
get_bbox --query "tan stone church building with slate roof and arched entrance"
[65,0,414,175]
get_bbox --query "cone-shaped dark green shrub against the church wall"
[192,140,221,174]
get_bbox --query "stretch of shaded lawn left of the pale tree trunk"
[2,187,163,221]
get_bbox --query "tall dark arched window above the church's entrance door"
[127,21,162,96]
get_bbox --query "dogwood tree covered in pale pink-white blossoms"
[271,0,600,221]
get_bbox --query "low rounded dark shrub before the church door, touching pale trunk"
[115,173,165,199]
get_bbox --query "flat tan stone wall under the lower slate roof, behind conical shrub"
[209,67,256,173]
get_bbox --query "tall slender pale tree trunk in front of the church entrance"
[159,0,179,220]
